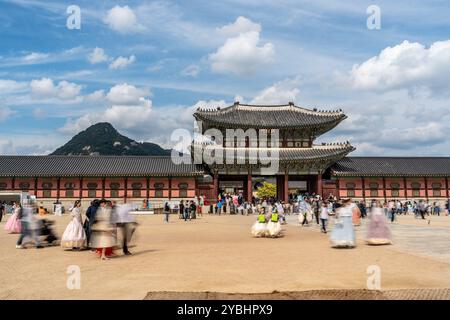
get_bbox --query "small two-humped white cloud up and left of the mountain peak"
[30,78,81,100]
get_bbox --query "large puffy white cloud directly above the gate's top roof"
[209,17,275,75]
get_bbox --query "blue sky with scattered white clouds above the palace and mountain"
[0,0,450,156]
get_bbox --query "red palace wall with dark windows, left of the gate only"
[0,177,197,209]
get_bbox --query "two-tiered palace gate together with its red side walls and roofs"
[0,102,450,208]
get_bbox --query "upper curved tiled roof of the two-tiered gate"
[194,102,347,134]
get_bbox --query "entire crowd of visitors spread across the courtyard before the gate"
[0,193,449,254]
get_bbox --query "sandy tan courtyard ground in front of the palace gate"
[0,215,450,299]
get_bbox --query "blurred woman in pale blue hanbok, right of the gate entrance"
[330,198,356,248]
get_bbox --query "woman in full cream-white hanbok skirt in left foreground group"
[61,200,86,249]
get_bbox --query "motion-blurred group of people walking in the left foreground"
[5,199,137,260]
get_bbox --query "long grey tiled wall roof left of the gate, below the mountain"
[0,156,203,177]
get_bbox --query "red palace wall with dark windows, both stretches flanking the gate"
[0,177,450,207]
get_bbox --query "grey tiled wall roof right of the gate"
[331,157,450,177]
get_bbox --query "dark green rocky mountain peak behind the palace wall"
[51,122,171,156]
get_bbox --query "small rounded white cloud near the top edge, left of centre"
[104,6,143,33]
